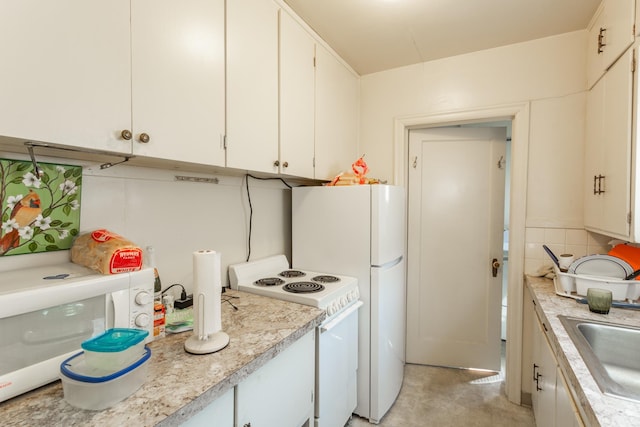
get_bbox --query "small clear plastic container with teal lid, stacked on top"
[82,328,149,372]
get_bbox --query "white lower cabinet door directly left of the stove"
[236,331,315,427]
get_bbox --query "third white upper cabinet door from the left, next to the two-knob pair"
[227,0,279,173]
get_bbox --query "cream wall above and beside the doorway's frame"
[359,31,588,272]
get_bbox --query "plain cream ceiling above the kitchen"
[285,0,600,75]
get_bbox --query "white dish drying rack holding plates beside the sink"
[553,265,640,309]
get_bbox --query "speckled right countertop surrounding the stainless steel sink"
[526,276,640,427]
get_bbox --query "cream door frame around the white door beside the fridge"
[394,102,530,405]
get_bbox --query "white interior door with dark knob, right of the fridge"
[407,128,506,371]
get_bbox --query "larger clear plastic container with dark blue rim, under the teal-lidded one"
[60,347,151,411]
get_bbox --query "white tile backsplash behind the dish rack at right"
[524,227,613,275]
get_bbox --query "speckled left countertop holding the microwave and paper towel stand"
[0,291,325,427]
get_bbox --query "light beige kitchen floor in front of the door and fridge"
[347,352,535,427]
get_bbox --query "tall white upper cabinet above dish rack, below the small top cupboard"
[584,49,637,240]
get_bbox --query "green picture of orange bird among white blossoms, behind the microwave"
[0,159,82,256]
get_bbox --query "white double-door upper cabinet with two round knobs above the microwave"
[0,0,224,165]
